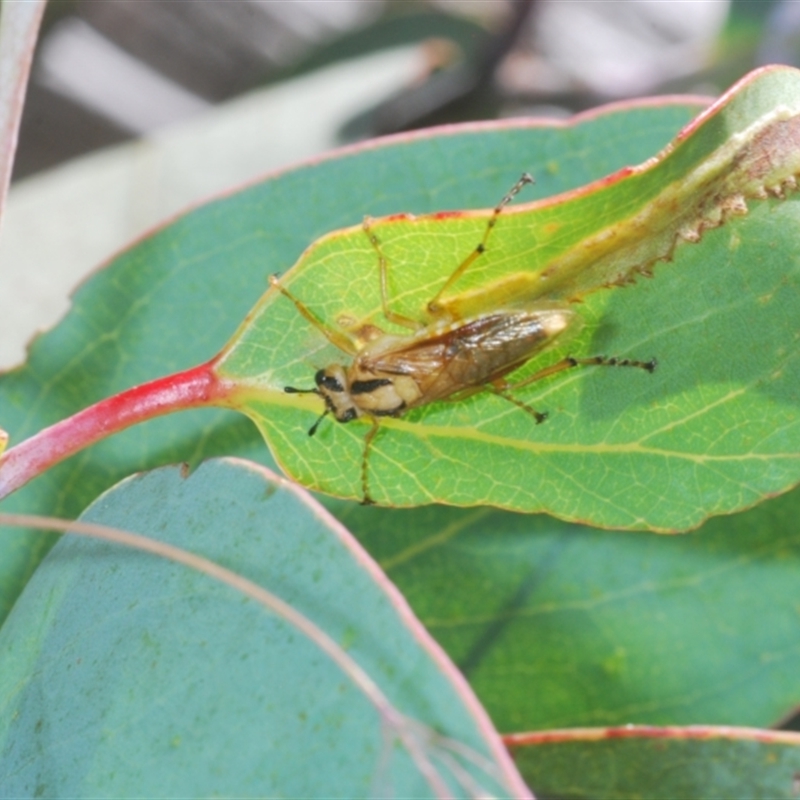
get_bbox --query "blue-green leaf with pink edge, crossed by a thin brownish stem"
[0,461,526,797]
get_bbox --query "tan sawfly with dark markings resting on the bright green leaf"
[270,173,656,504]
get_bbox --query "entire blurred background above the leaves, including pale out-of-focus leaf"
[0,0,800,368]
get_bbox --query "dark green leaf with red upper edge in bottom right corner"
[506,726,800,800]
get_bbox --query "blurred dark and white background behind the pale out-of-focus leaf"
[15,0,800,178]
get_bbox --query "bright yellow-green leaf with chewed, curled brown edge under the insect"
[218,68,800,531]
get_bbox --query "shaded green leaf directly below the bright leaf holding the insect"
[338,482,800,732]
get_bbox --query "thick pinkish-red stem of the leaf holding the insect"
[0,361,233,500]
